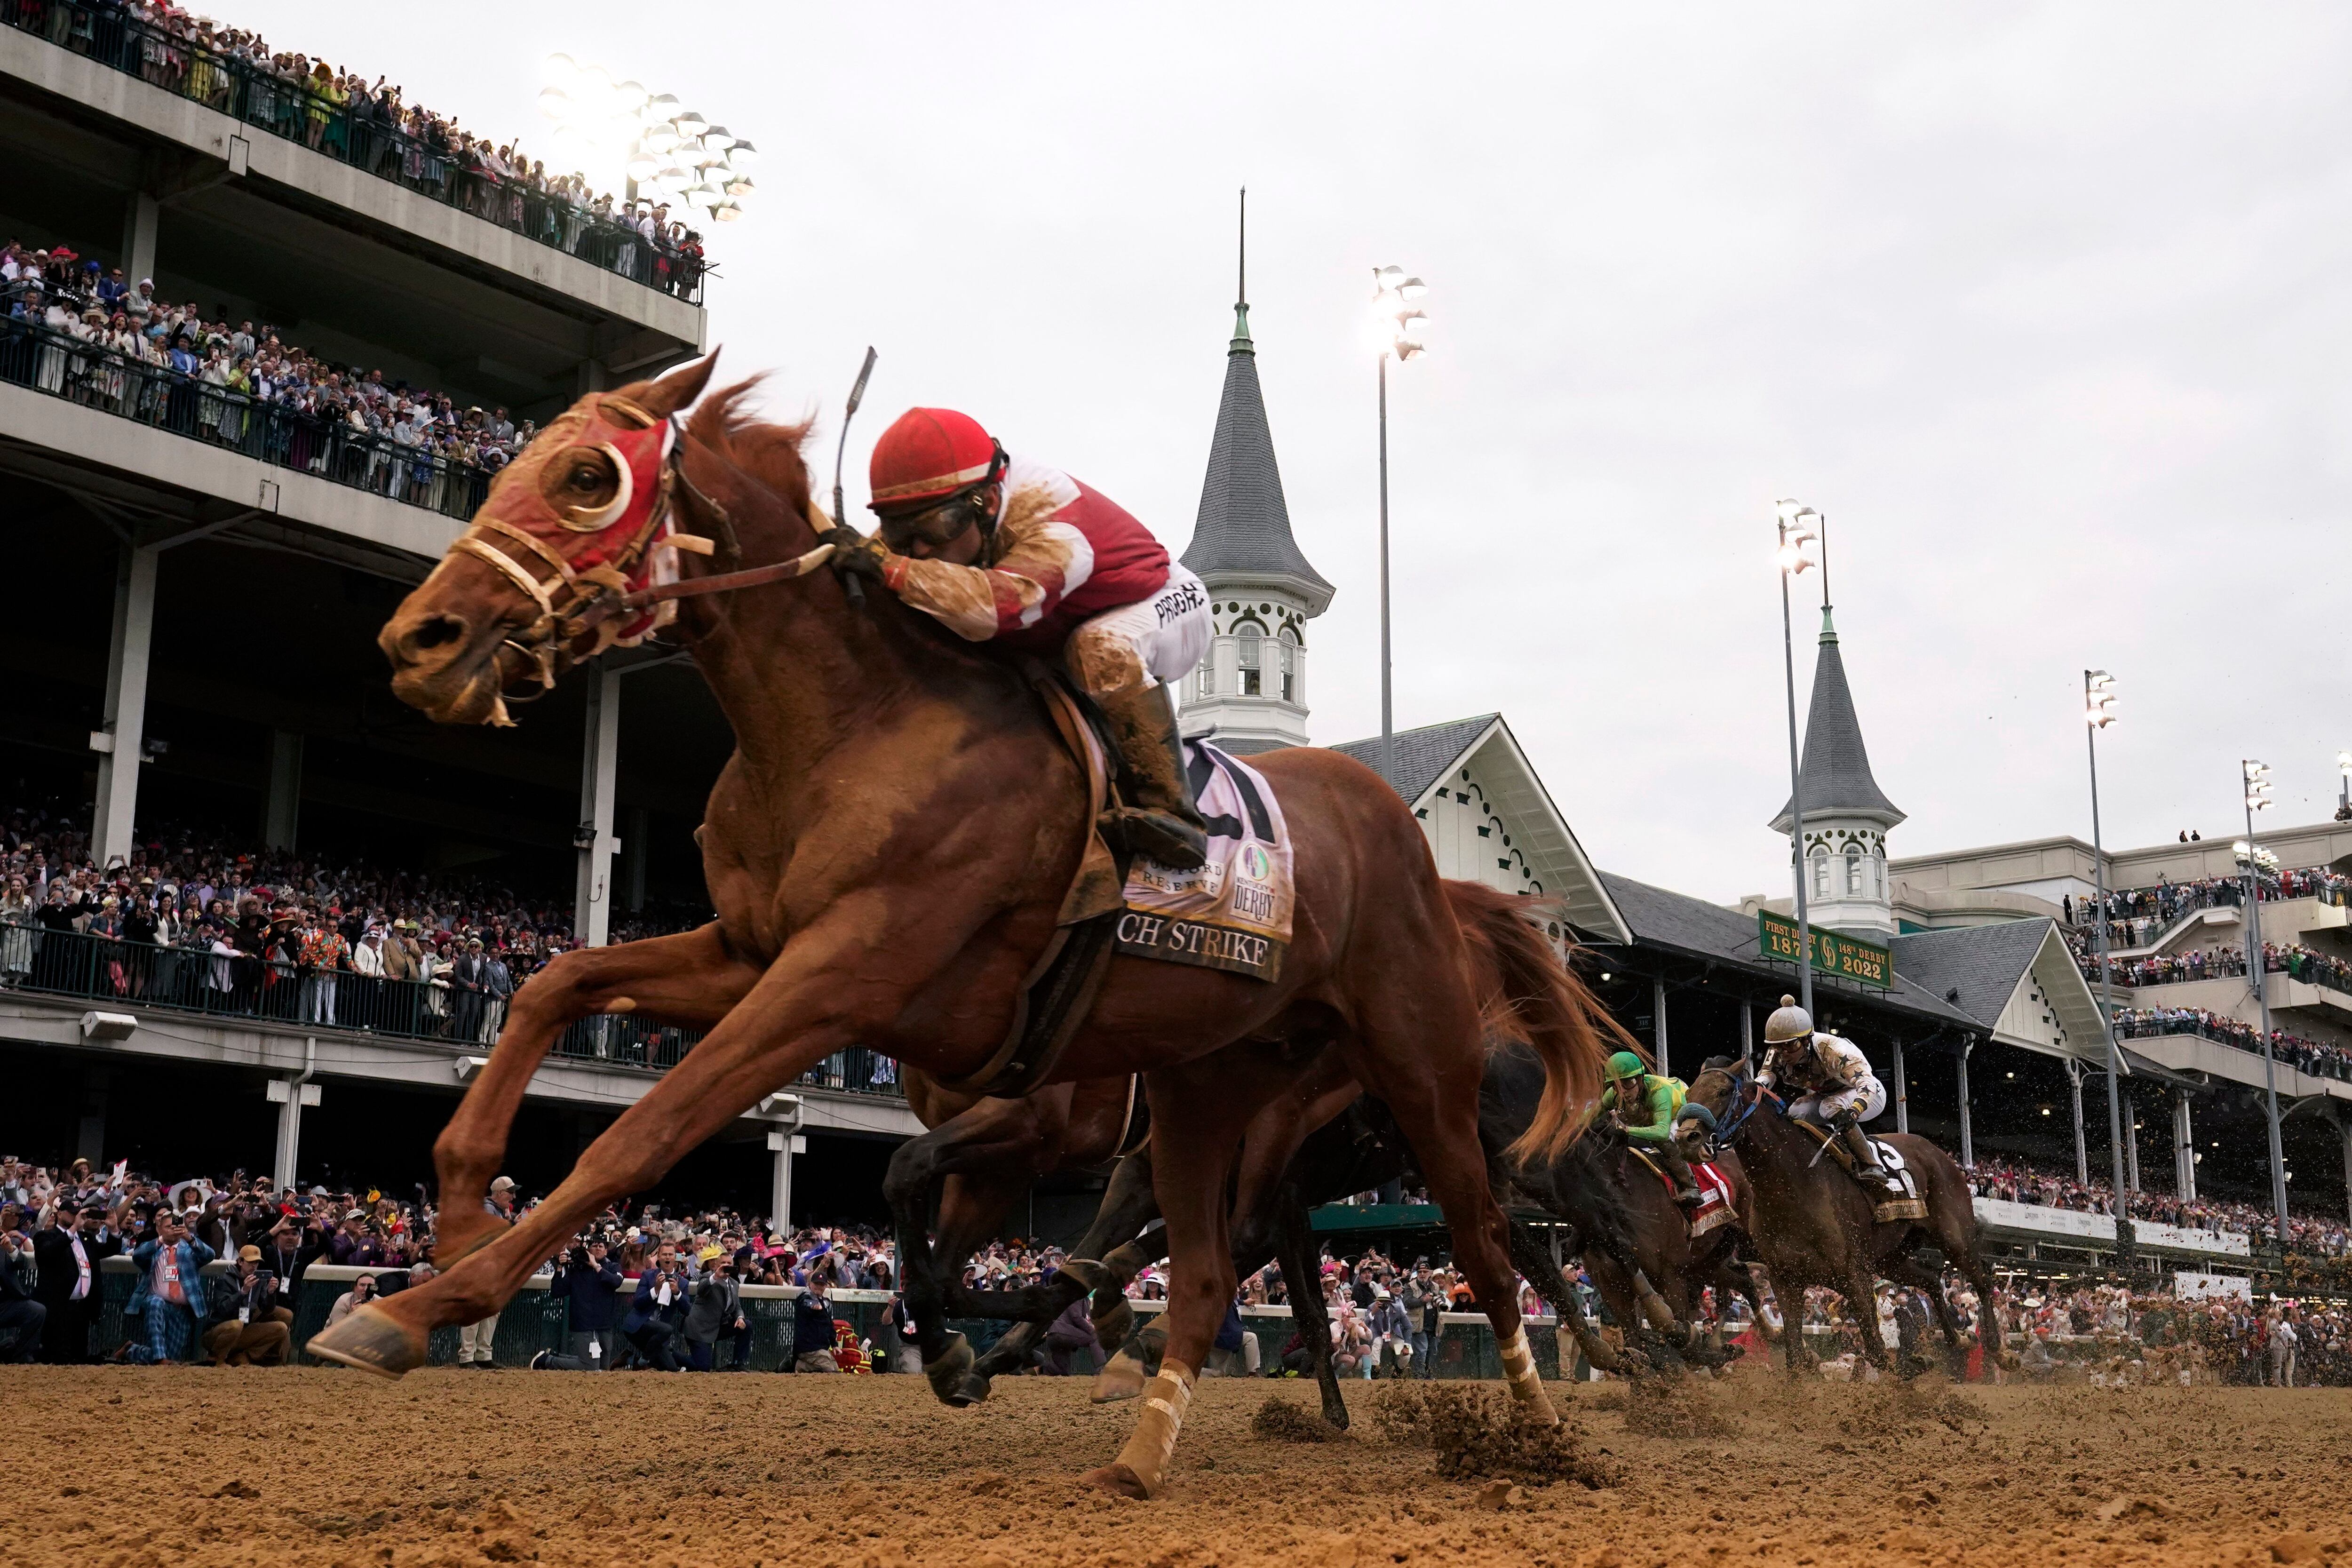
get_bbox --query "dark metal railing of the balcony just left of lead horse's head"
[0,315,492,519]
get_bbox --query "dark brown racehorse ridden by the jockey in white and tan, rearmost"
[1691,1058,2002,1370]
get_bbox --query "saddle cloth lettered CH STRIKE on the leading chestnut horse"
[1115,740,1296,980]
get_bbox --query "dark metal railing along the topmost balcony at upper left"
[0,0,708,306]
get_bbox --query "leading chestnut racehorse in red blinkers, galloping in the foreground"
[310,360,1602,1497]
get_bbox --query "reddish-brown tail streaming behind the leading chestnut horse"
[1444,882,1635,1162]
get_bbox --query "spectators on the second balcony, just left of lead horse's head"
[0,240,536,517]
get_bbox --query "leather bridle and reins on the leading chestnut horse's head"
[452,411,833,700]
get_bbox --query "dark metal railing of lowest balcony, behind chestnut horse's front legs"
[0,926,906,1098]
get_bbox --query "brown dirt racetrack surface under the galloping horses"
[0,1366,2352,1568]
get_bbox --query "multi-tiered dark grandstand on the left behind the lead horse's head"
[0,18,915,1208]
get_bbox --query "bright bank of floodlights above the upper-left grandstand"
[539,54,760,223]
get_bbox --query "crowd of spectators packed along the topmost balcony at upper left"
[0,0,708,299]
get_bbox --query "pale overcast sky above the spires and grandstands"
[248,0,2352,900]
